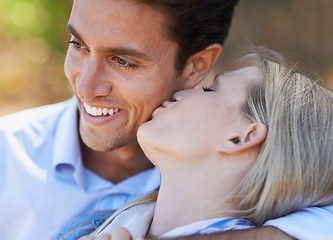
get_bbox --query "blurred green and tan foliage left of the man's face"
[0,0,71,114]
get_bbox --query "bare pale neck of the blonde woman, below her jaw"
[148,166,237,237]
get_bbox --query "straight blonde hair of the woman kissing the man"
[238,50,333,226]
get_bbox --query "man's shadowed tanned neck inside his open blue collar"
[81,142,153,184]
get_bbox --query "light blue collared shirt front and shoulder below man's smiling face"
[0,98,160,240]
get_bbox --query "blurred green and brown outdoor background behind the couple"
[0,0,333,116]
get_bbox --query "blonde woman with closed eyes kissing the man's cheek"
[82,53,333,239]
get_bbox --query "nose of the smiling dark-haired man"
[75,58,112,100]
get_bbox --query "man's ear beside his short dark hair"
[182,43,222,89]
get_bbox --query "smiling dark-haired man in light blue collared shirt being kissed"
[0,0,330,240]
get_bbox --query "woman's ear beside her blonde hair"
[216,123,267,154]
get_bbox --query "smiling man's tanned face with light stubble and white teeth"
[65,0,183,151]
